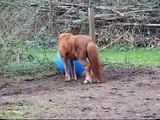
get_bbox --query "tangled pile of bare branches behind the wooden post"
[49,0,160,48]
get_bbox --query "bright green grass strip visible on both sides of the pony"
[25,48,160,67]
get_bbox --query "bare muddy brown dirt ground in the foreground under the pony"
[0,68,160,119]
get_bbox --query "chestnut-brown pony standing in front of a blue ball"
[58,33,103,84]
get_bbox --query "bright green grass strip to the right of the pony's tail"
[100,48,160,67]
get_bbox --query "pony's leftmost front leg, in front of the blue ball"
[63,58,71,82]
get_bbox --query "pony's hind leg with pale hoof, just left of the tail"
[80,59,92,84]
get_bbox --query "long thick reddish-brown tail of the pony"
[87,42,103,82]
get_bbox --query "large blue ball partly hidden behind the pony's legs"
[55,52,84,75]
